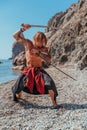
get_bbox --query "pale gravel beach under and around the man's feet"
[0,65,87,130]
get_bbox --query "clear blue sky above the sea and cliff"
[0,0,78,59]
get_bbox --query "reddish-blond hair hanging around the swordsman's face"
[33,32,47,45]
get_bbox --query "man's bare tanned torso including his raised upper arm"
[14,31,50,67]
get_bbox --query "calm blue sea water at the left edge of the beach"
[0,59,20,83]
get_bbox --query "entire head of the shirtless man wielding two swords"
[33,32,47,47]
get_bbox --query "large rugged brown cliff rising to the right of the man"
[46,0,87,69]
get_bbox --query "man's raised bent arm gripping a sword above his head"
[13,24,31,43]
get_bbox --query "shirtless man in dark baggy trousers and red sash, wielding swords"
[12,24,58,107]
